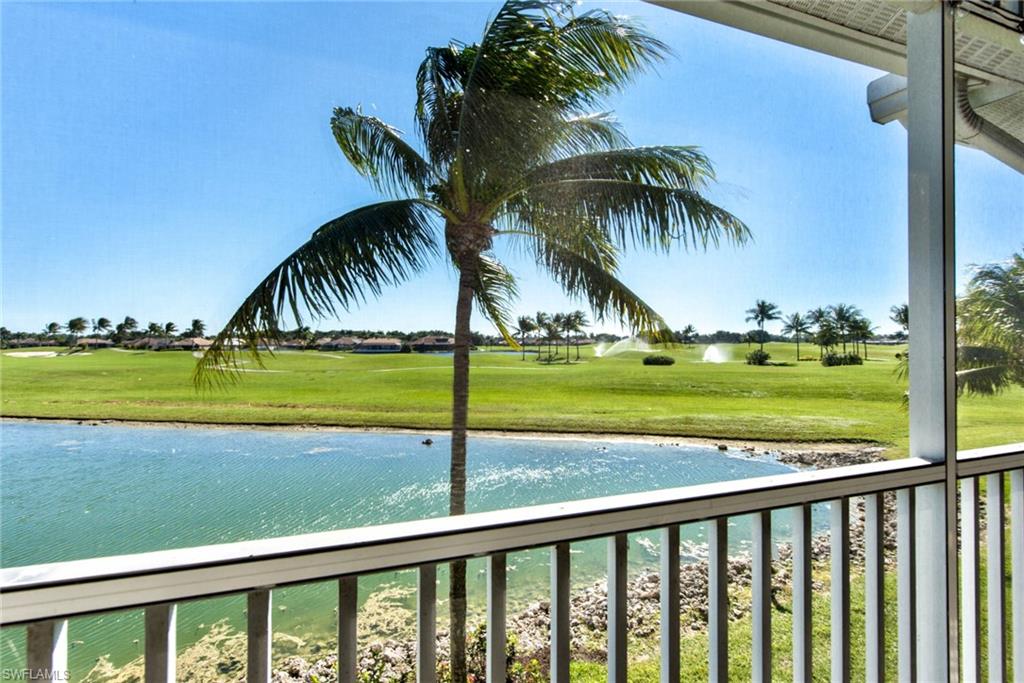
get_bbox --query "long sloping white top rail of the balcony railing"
[0,444,1024,626]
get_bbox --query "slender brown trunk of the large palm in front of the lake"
[449,255,477,683]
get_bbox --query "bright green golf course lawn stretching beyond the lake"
[0,344,1024,455]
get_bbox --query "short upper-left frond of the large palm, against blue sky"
[331,106,435,197]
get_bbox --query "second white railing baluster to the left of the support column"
[864,494,886,681]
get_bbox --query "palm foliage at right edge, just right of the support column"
[956,252,1024,394]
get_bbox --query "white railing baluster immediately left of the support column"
[896,488,918,681]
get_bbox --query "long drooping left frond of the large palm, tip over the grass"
[193,200,437,386]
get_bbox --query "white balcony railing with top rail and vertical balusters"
[0,443,1024,683]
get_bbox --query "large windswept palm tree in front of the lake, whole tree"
[196,0,749,671]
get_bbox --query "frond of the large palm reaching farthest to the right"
[504,179,750,251]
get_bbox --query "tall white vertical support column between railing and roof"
[906,1,959,682]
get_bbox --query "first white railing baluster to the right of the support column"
[961,477,981,683]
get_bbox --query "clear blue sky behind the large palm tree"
[0,2,1024,332]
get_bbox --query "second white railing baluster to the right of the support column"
[985,473,1007,683]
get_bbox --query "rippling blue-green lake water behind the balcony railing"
[0,422,806,671]
